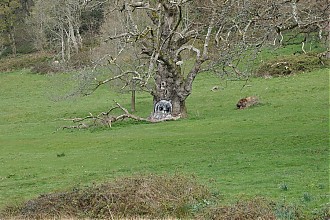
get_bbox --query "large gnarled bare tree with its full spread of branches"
[78,0,329,122]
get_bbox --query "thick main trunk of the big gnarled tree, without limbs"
[147,0,188,117]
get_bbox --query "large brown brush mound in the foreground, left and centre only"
[0,175,210,219]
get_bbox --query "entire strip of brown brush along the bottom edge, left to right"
[0,174,330,220]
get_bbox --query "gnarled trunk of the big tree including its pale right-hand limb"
[153,1,216,117]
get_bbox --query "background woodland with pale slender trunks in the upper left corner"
[0,0,104,57]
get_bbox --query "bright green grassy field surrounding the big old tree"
[0,66,329,217]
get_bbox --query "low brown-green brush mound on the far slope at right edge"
[256,52,330,77]
